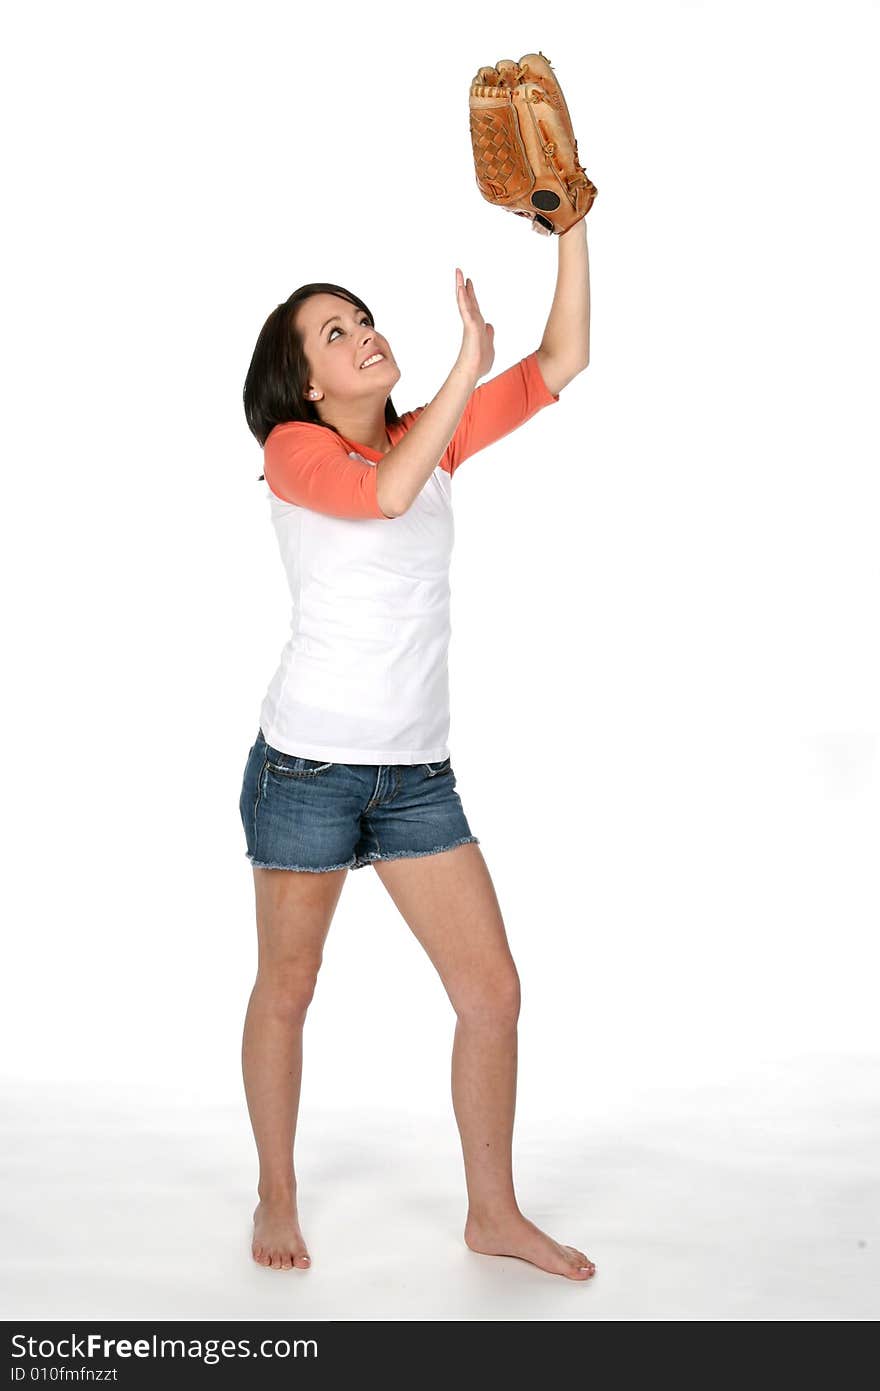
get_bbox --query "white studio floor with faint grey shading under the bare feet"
[1,1056,880,1320]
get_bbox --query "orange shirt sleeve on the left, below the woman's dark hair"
[263,420,391,520]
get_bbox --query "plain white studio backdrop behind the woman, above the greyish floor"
[1,0,880,1316]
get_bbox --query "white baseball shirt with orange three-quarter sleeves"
[260,352,559,764]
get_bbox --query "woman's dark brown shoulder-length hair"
[243,281,400,483]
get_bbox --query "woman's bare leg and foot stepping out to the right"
[373,843,595,1280]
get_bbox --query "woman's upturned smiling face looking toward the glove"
[296,295,400,403]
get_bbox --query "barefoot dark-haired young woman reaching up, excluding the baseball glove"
[241,220,595,1280]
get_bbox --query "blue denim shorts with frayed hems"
[239,729,480,872]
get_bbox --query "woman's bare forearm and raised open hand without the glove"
[375,267,495,517]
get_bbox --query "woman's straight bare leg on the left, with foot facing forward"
[242,867,348,1270]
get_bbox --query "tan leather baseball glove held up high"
[470,51,598,236]
